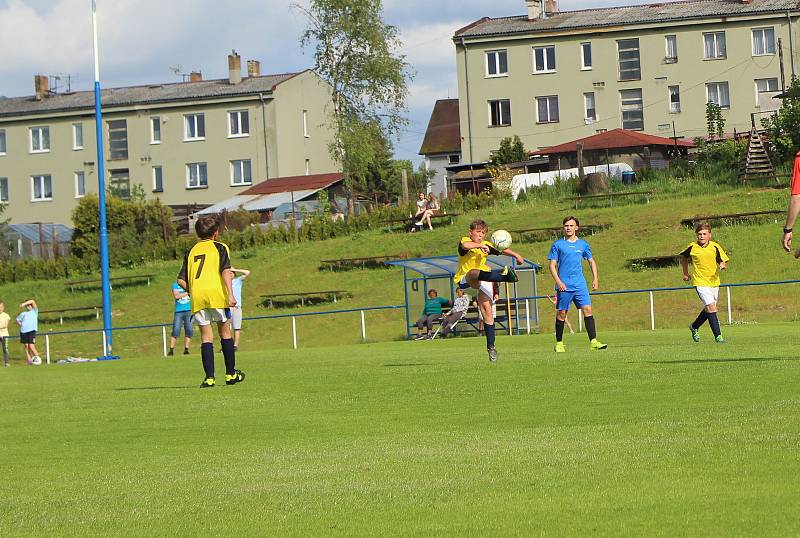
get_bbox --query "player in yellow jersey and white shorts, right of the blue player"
[680,222,730,344]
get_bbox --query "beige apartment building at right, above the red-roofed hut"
[453,0,800,162]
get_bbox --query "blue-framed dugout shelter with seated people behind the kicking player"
[384,255,541,338]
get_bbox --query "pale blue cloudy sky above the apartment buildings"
[0,0,643,165]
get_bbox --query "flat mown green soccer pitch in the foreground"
[0,323,800,536]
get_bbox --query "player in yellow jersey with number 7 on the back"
[178,216,245,388]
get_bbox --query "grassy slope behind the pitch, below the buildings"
[0,184,798,356]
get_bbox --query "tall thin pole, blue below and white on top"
[92,0,113,356]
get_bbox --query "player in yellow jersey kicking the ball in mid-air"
[453,219,525,362]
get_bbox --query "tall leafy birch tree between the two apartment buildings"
[292,0,411,203]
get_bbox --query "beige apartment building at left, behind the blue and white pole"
[0,53,338,226]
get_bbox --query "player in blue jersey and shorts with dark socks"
[547,216,608,353]
